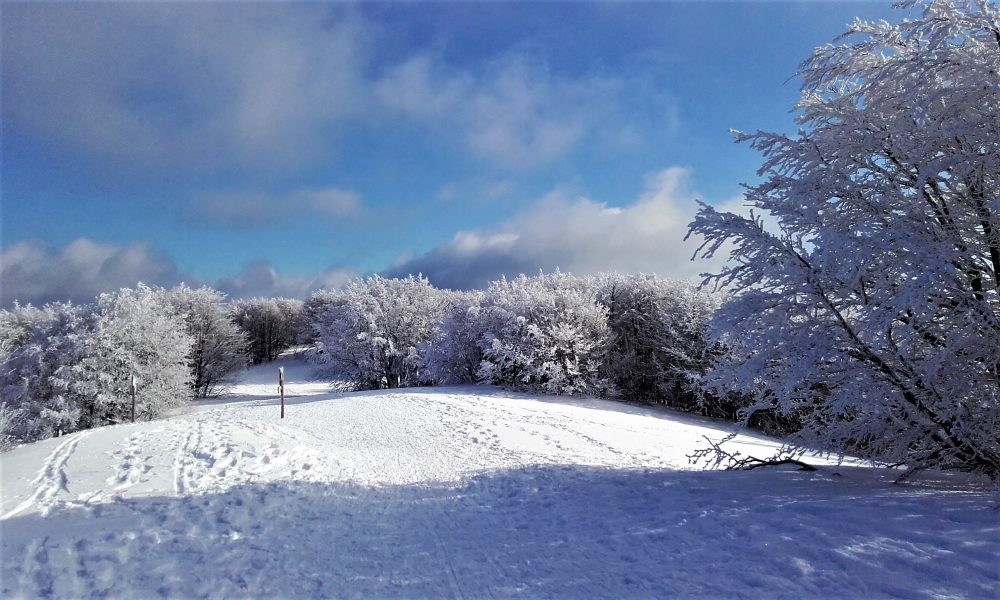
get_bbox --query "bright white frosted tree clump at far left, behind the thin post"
[0,284,192,441]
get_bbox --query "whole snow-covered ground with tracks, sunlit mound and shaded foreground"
[0,357,1000,598]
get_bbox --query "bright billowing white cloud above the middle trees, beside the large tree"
[389,167,732,288]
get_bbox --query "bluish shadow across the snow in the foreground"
[0,466,1000,598]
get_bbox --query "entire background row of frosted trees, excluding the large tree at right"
[0,272,738,445]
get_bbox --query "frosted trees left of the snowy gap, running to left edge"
[0,284,305,446]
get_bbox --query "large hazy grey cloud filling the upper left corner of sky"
[3,3,369,169]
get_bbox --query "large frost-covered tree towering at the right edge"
[691,0,1000,478]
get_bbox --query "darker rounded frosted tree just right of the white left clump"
[168,284,247,398]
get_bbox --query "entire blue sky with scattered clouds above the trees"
[0,2,901,304]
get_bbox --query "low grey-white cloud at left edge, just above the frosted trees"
[0,238,192,305]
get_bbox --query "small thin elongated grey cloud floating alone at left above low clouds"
[190,187,362,228]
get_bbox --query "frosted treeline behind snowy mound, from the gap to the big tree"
[305,273,735,418]
